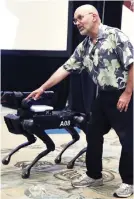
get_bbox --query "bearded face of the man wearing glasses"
[74,10,94,35]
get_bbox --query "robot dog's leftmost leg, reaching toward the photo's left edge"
[2,132,36,165]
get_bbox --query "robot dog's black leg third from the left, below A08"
[55,127,80,164]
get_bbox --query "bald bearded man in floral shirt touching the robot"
[27,5,134,197]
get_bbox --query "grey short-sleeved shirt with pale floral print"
[63,24,134,90]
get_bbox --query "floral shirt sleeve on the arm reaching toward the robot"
[63,42,84,73]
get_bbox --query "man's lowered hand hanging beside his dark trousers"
[117,91,132,112]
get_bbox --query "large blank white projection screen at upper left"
[0,0,72,56]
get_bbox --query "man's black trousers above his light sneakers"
[86,90,133,184]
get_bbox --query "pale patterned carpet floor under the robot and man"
[1,107,133,199]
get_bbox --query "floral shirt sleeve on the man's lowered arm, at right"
[116,31,134,70]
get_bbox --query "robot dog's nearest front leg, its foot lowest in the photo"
[22,129,55,178]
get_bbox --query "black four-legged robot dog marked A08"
[1,91,89,178]
